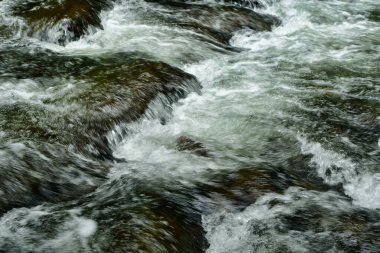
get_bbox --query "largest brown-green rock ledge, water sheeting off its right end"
[0,51,201,159]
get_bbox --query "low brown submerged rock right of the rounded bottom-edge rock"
[193,155,344,211]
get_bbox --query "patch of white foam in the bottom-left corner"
[0,206,97,253]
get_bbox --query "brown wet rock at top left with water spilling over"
[12,0,113,45]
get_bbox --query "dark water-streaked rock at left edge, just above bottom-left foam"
[0,140,110,215]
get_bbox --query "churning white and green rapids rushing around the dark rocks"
[0,0,380,253]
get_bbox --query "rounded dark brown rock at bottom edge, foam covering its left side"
[0,173,207,253]
